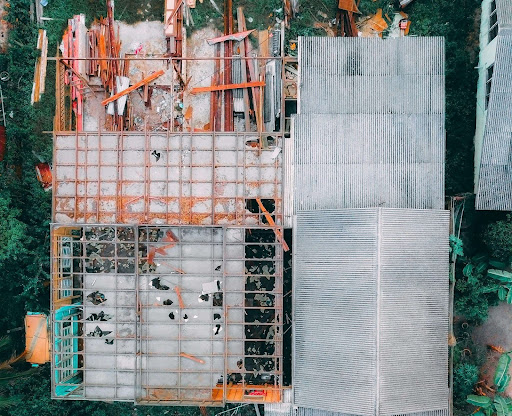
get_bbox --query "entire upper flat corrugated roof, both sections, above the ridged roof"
[294,38,445,212]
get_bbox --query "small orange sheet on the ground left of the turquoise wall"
[25,313,50,364]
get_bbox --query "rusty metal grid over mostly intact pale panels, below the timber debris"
[52,131,284,226]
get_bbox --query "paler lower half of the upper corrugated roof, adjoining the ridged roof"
[292,114,445,211]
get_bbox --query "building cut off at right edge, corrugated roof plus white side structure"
[475,0,512,211]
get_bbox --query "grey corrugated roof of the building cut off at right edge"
[476,31,512,211]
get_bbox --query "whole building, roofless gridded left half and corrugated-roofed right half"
[48,1,450,416]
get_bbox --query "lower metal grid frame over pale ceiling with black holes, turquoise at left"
[51,224,283,406]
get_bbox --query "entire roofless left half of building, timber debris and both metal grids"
[51,2,288,406]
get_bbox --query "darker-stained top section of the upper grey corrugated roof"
[299,37,445,115]
